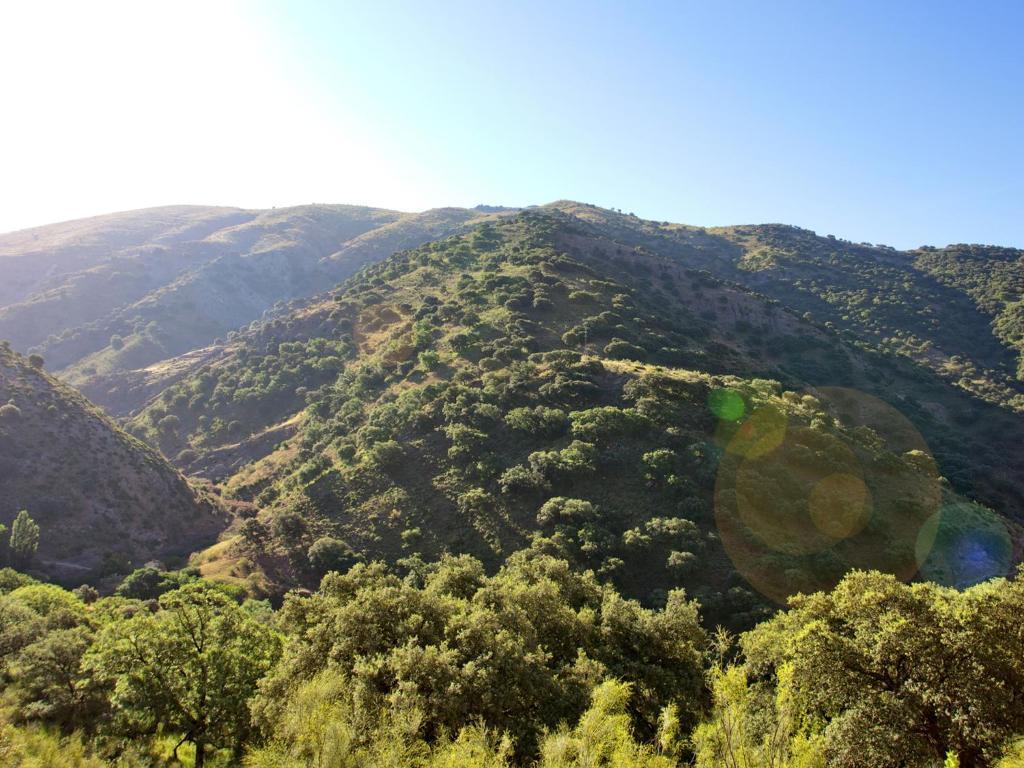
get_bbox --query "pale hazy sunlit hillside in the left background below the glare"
[0,206,509,414]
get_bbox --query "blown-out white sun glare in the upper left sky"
[0,2,424,231]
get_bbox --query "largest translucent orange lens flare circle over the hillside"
[715,387,937,604]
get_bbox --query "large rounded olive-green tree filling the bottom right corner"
[720,571,1024,768]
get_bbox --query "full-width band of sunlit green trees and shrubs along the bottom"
[0,547,1024,768]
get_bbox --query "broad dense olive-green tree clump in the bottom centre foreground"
[253,551,706,765]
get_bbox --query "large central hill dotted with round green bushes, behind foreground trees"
[130,206,1024,614]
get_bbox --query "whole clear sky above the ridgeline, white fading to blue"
[0,0,1024,248]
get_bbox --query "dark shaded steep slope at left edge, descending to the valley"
[0,344,226,582]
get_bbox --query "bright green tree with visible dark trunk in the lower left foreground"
[90,583,280,768]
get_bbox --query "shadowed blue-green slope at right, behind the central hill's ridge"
[550,201,1024,412]
